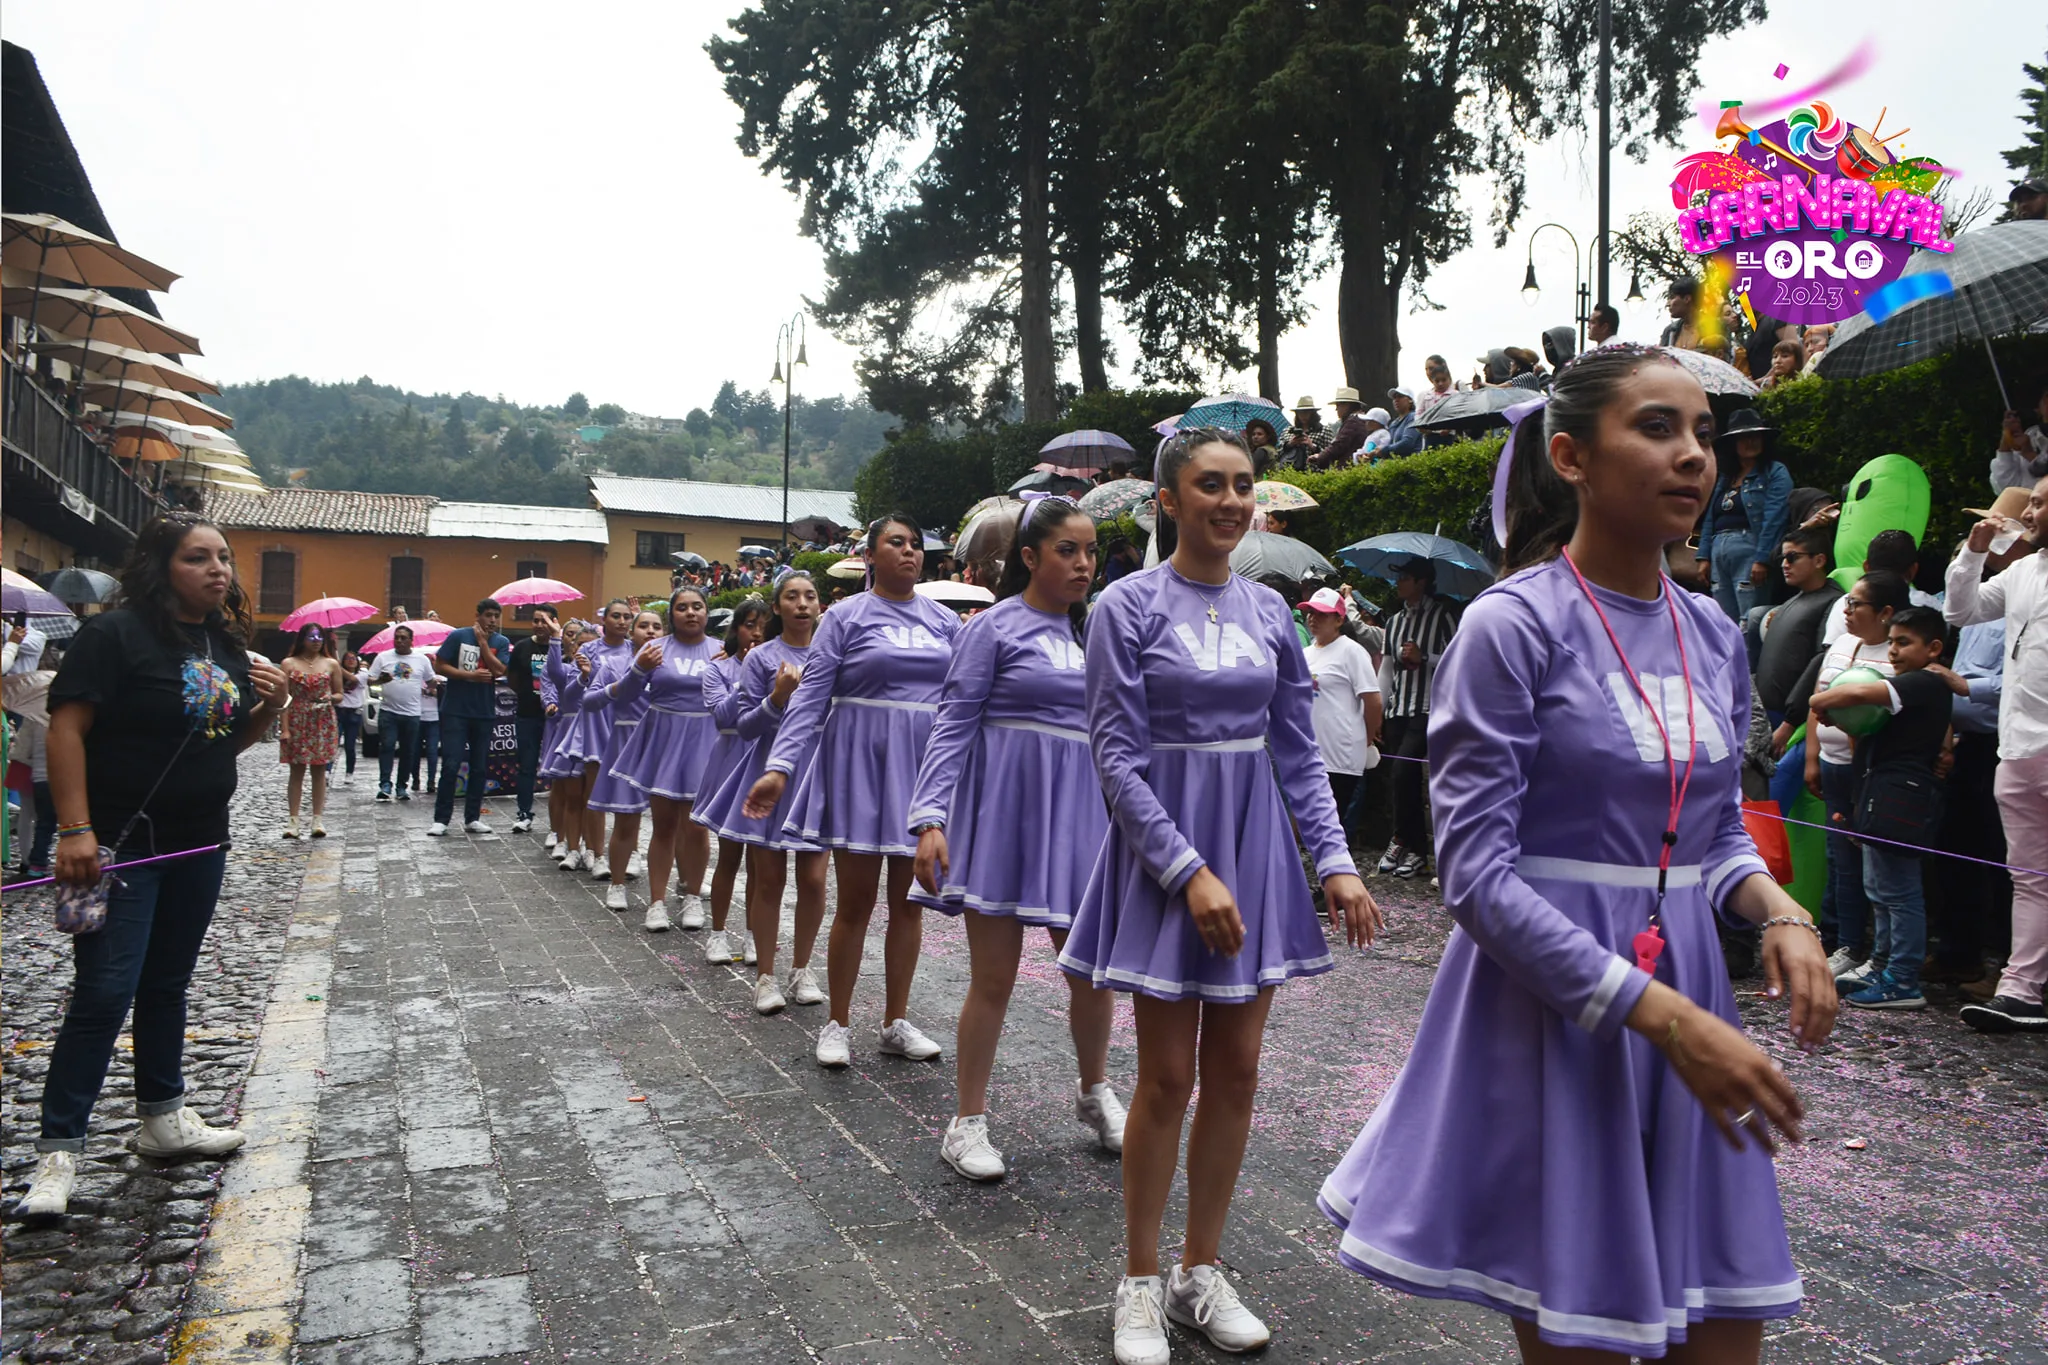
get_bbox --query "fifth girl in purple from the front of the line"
[694,571,827,1013]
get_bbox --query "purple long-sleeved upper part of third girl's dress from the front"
[909,598,1087,829]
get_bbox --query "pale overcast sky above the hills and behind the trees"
[0,0,2048,415]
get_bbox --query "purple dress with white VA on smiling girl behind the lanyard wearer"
[1059,565,1358,1001]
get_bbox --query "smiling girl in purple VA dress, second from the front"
[1059,428,1378,1365]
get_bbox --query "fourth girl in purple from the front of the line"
[745,516,961,1066]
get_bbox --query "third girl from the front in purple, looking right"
[909,497,1124,1181]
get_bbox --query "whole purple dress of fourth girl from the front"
[766,591,961,857]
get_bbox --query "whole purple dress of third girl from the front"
[909,598,1108,929]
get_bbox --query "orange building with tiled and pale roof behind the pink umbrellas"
[207,489,610,649]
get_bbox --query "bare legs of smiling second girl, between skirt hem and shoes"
[1124,988,1274,1275]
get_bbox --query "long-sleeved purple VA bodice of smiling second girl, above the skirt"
[1085,565,1358,894]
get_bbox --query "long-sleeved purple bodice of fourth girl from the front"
[766,591,961,774]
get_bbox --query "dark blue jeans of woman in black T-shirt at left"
[35,847,227,1152]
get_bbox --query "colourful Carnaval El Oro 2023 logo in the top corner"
[1671,53,1956,325]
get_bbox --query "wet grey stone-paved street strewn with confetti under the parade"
[0,765,2048,1365]
